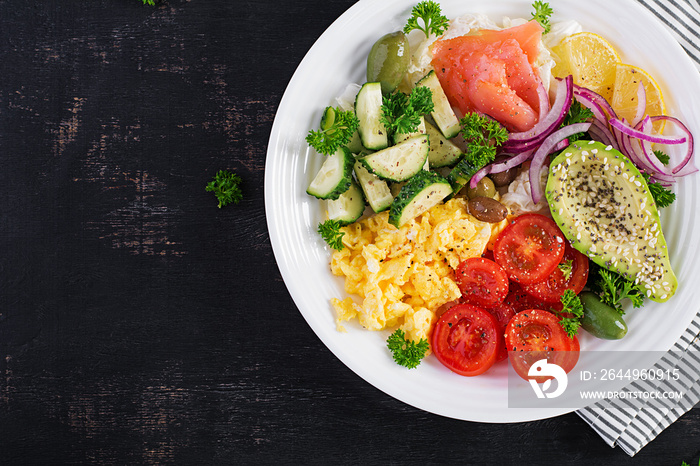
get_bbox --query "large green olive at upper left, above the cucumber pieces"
[367,31,410,93]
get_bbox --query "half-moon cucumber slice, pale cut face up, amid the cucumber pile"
[359,134,430,181]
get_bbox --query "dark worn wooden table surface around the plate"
[0,0,700,466]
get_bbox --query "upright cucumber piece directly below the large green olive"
[355,83,389,150]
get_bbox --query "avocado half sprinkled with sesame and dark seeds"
[546,141,678,302]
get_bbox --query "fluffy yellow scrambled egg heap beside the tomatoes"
[331,198,494,341]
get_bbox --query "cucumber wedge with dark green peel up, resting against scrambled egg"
[389,170,452,228]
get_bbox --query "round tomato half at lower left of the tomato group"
[432,304,503,376]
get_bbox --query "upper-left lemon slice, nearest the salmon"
[552,32,621,102]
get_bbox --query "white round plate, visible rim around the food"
[265,0,700,422]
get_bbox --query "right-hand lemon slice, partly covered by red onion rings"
[610,63,666,133]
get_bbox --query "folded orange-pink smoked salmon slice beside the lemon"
[431,21,543,132]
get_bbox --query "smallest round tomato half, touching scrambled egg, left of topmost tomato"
[455,257,508,307]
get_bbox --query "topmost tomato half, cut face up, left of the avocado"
[493,214,566,284]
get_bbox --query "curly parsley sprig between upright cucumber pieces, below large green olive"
[380,86,434,135]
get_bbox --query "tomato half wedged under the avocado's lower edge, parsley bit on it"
[523,242,588,303]
